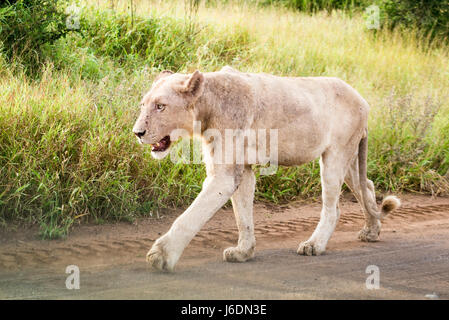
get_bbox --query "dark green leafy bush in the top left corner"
[0,0,68,74]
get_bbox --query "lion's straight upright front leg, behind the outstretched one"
[223,166,256,262]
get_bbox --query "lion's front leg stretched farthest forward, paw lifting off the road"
[147,174,238,271]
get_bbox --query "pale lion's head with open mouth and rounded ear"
[133,71,204,159]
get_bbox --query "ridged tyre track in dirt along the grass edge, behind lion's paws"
[0,204,449,270]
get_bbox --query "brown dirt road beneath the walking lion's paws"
[0,195,449,299]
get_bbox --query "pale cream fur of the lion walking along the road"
[134,67,400,270]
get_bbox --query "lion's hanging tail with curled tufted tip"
[359,136,401,219]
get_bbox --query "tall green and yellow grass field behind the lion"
[0,1,449,238]
